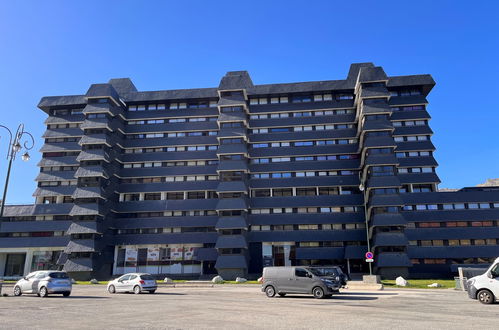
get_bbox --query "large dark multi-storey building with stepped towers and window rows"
[0,63,499,278]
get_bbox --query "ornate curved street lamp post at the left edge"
[0,124,35,218]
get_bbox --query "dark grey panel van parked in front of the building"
[262,266,341,299]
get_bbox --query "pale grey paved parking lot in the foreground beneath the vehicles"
[0,284,499,329]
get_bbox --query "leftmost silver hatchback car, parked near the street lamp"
[14,270,72,298]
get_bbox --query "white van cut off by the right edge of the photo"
[467,258,499,304]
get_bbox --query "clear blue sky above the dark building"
[0,0,499,203]
